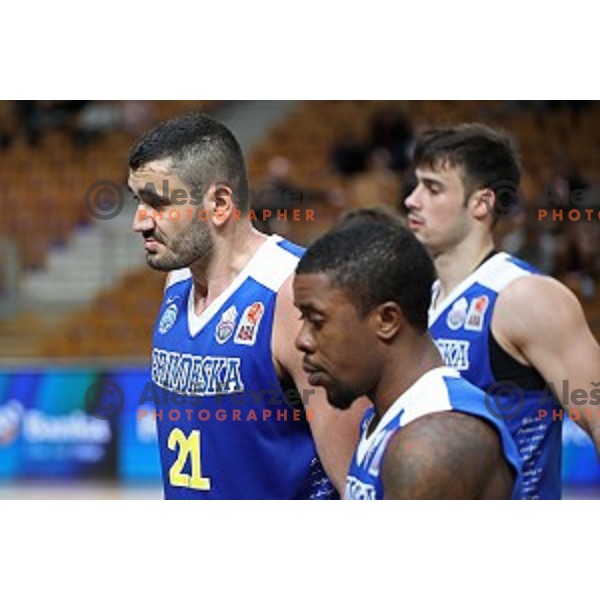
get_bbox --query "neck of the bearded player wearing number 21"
[190,223,267,314]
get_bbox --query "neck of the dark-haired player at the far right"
[434,233,494,304]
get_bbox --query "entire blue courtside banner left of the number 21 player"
[0,366,160,480]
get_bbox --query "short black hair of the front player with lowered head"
[296,223,435,332]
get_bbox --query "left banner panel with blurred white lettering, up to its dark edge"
[0,368,116,478]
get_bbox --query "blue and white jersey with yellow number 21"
[152,236,337,499]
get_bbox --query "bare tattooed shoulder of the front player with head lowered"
[381,411,514,500]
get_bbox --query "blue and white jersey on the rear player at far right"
[429,252,562,499]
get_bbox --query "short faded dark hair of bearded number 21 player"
[129,113,249,212]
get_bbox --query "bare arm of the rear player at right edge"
[492,276,600,451]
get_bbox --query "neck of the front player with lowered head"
[369,333,444,428]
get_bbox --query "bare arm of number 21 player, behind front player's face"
[273,277,368,493]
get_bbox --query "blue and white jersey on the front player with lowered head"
[344,367,521,500]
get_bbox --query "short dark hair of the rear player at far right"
[413,123,521,218]
